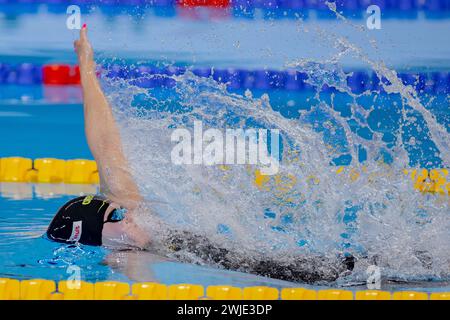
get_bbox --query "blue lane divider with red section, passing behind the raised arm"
[0,63,450,94]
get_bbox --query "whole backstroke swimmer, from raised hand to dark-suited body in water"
[46,25,353,283]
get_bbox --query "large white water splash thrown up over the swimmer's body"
[99,9,450,281]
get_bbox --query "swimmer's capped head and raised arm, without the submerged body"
[47,25,150,248]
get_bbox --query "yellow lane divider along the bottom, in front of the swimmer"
[0,278,450,300]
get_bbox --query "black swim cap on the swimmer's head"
[47,195,120,246]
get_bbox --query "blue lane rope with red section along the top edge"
[0,0,450,20]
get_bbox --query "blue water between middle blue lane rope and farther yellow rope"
[0,85,450,168]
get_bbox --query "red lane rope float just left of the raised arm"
[42,64,80,85]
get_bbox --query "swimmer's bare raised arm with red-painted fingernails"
[74,25,141,210]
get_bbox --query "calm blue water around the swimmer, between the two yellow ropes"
[0,189,449,291]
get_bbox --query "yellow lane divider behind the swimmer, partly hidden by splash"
[0,157,450,194]
